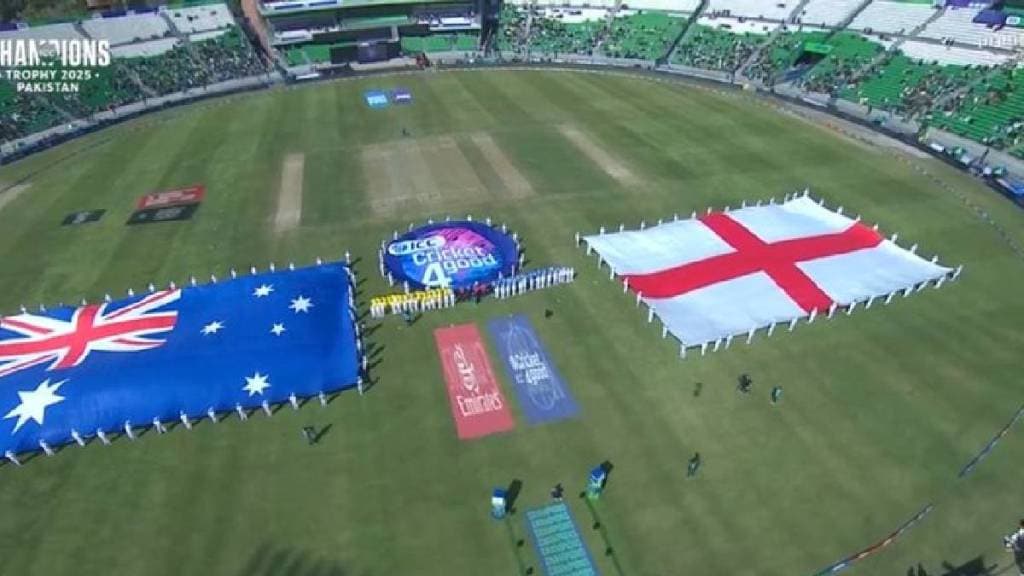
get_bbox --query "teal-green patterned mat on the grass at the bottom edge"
[526,502,598,576]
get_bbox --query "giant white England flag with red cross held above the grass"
[584,196,952,346]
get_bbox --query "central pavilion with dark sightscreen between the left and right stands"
[258,0,484,72]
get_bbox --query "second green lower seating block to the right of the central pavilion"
[601,11,685,59]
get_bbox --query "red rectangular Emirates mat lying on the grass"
[434,324,515,440]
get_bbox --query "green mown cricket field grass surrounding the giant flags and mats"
[0,72,1024,576]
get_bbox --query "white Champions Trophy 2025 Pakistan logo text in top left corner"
[0,38,111,93]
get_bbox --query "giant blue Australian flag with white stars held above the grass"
[0,263,359,454]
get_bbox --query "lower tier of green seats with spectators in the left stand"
[0,29,267,141]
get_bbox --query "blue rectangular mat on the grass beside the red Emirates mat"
[487,315,580,425]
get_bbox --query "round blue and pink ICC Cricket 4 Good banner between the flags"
[384,220,519,290]
